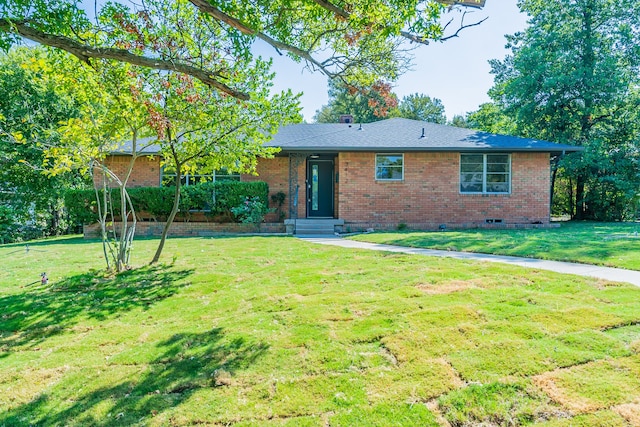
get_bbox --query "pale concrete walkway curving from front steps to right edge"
[299,236,640,287]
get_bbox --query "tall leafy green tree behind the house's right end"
[490,0,640,219]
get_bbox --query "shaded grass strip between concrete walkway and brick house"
[352,222,640,270]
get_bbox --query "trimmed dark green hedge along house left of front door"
[65,181,269,224]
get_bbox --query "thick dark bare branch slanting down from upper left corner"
[0,20,249,100]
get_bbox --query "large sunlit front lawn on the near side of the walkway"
[0,237,640,426]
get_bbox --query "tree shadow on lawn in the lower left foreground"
[0,328,268,426]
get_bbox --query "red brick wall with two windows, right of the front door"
[338,153,550,228]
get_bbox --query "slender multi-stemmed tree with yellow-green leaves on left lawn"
[44,52,151,272]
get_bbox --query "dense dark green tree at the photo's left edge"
[0,48,86,238]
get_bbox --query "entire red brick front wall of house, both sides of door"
[96,153,550,230]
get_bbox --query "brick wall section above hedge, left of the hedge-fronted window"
[93,156,160,188]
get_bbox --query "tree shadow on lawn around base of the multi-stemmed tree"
[0,265,193,359]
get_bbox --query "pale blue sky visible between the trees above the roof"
[259,0,527,122]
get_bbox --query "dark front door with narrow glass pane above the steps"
[307,159,333,218]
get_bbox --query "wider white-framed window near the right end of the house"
[460,154,511,194]
